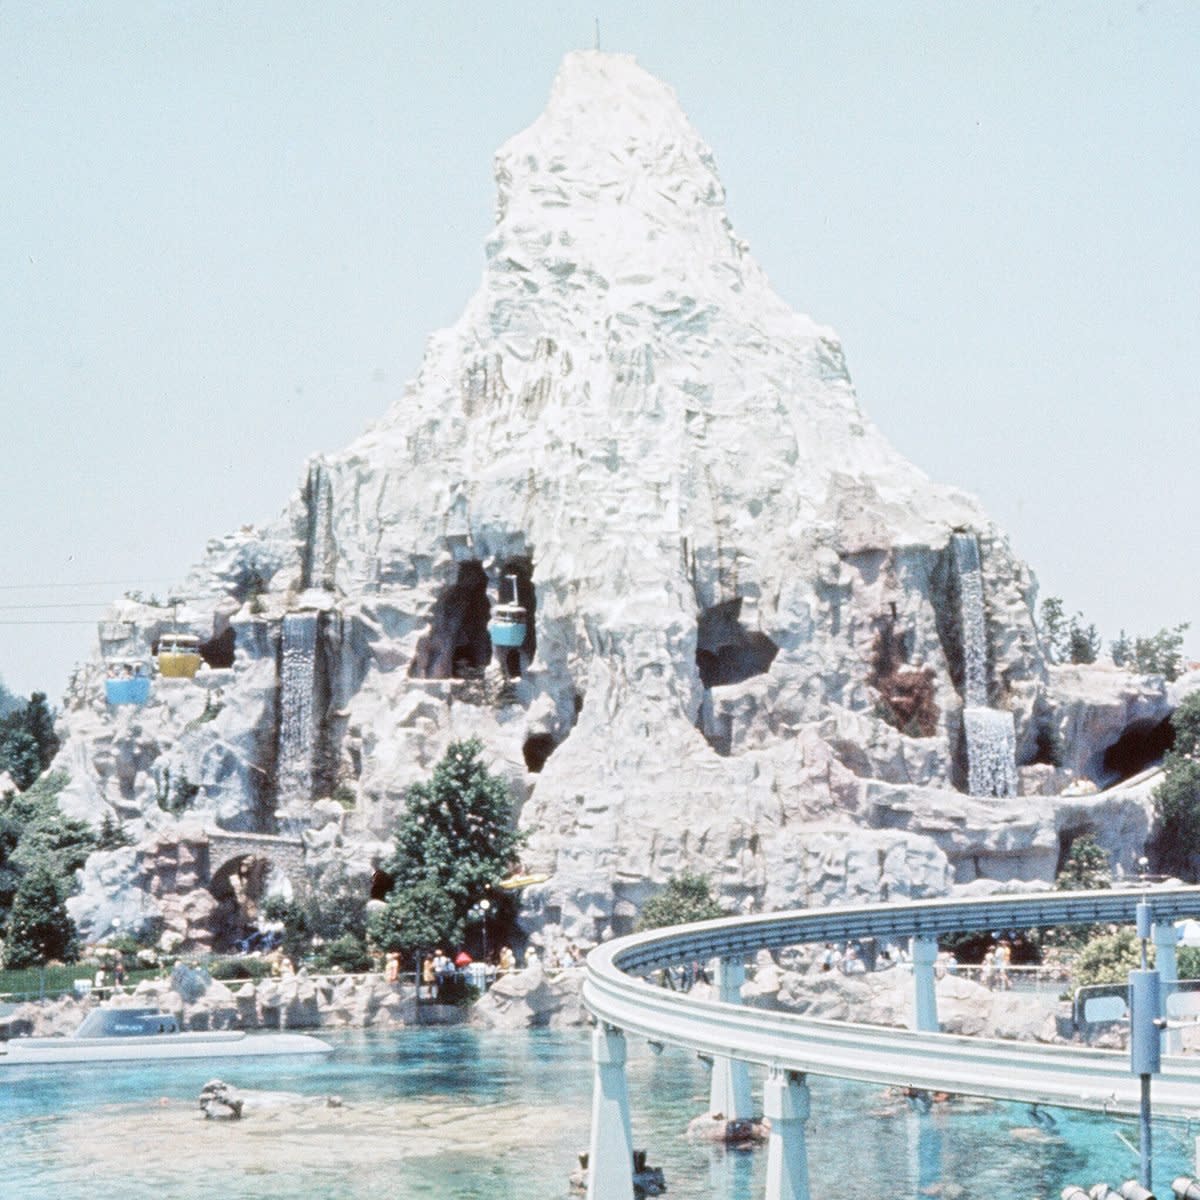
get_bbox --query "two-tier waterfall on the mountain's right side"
[950,533,1016,796]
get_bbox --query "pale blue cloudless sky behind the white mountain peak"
[0,0,1200,698]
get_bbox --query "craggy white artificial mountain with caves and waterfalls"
[56,52,1177,947]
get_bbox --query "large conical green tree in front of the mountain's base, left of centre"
[374,738,524,952]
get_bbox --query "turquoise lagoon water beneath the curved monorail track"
[0,1028,1194,1200]
